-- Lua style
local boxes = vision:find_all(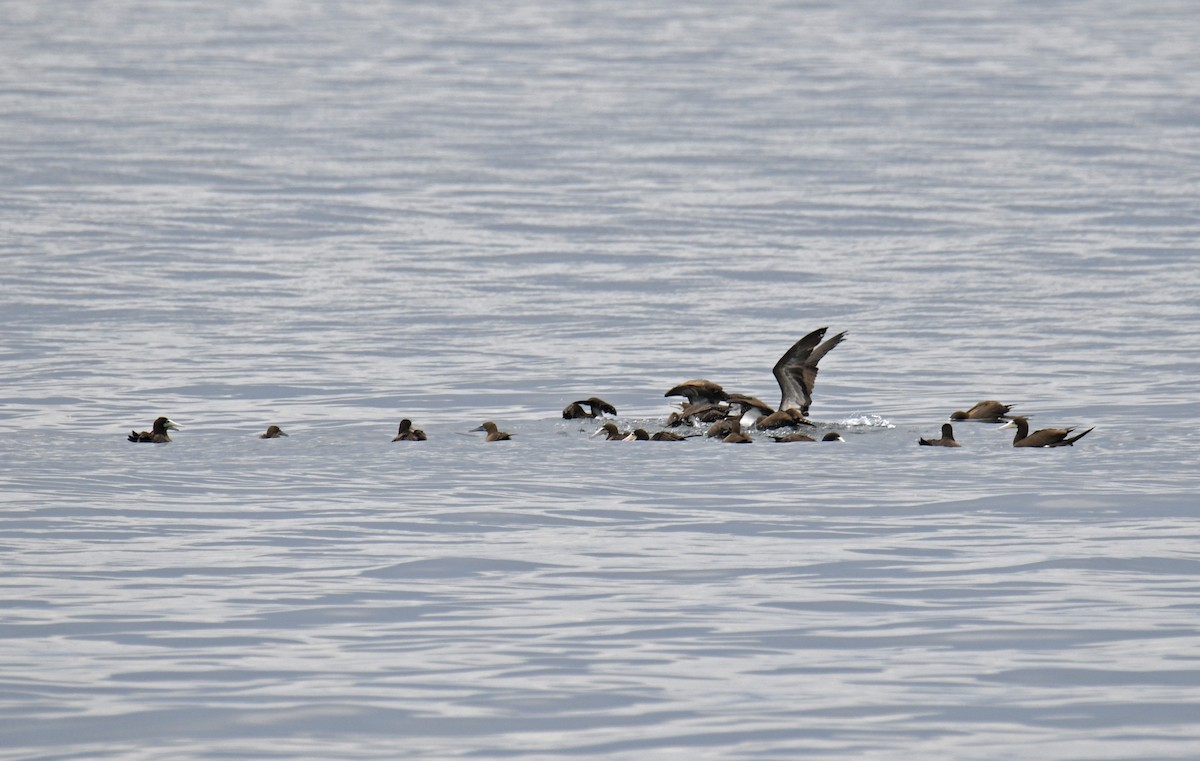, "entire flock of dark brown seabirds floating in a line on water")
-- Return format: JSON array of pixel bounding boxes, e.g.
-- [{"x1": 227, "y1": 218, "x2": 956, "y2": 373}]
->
[{"x1": 128, "y1": 328, "x2": 1093, "y2": 447}]
